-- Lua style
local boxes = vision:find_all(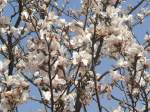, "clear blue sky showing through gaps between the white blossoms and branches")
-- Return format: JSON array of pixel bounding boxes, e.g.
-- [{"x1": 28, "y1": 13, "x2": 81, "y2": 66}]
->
[{"x1": 4, "y1": 0, "x2": 150, "y2": 112}]
